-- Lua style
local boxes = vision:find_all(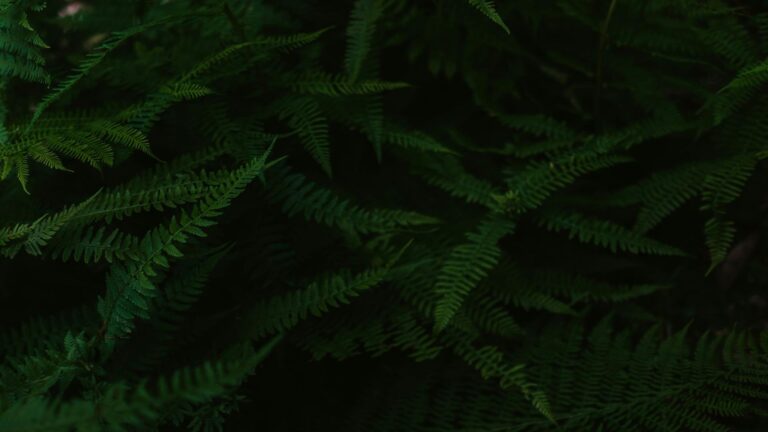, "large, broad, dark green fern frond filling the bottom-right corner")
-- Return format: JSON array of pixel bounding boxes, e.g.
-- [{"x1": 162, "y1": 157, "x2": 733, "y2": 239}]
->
[{"x1": 510, "y1": 320, "x2": 768, "y2": 431}]
